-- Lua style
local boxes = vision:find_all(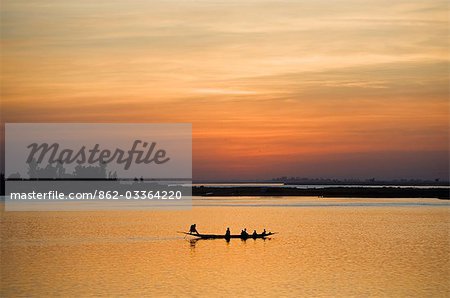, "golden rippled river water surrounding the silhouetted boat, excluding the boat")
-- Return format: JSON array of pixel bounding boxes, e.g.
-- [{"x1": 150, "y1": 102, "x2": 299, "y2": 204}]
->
[{"x1": 0, "y1": 197, "x2": 450, "y2": 297}]
